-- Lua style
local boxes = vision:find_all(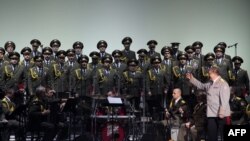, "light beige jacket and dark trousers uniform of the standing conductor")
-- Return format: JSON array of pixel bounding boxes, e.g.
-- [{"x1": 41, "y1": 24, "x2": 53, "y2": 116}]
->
[{"x1": 190, "y1": 76, "x2": 231, "y2": 141}]
